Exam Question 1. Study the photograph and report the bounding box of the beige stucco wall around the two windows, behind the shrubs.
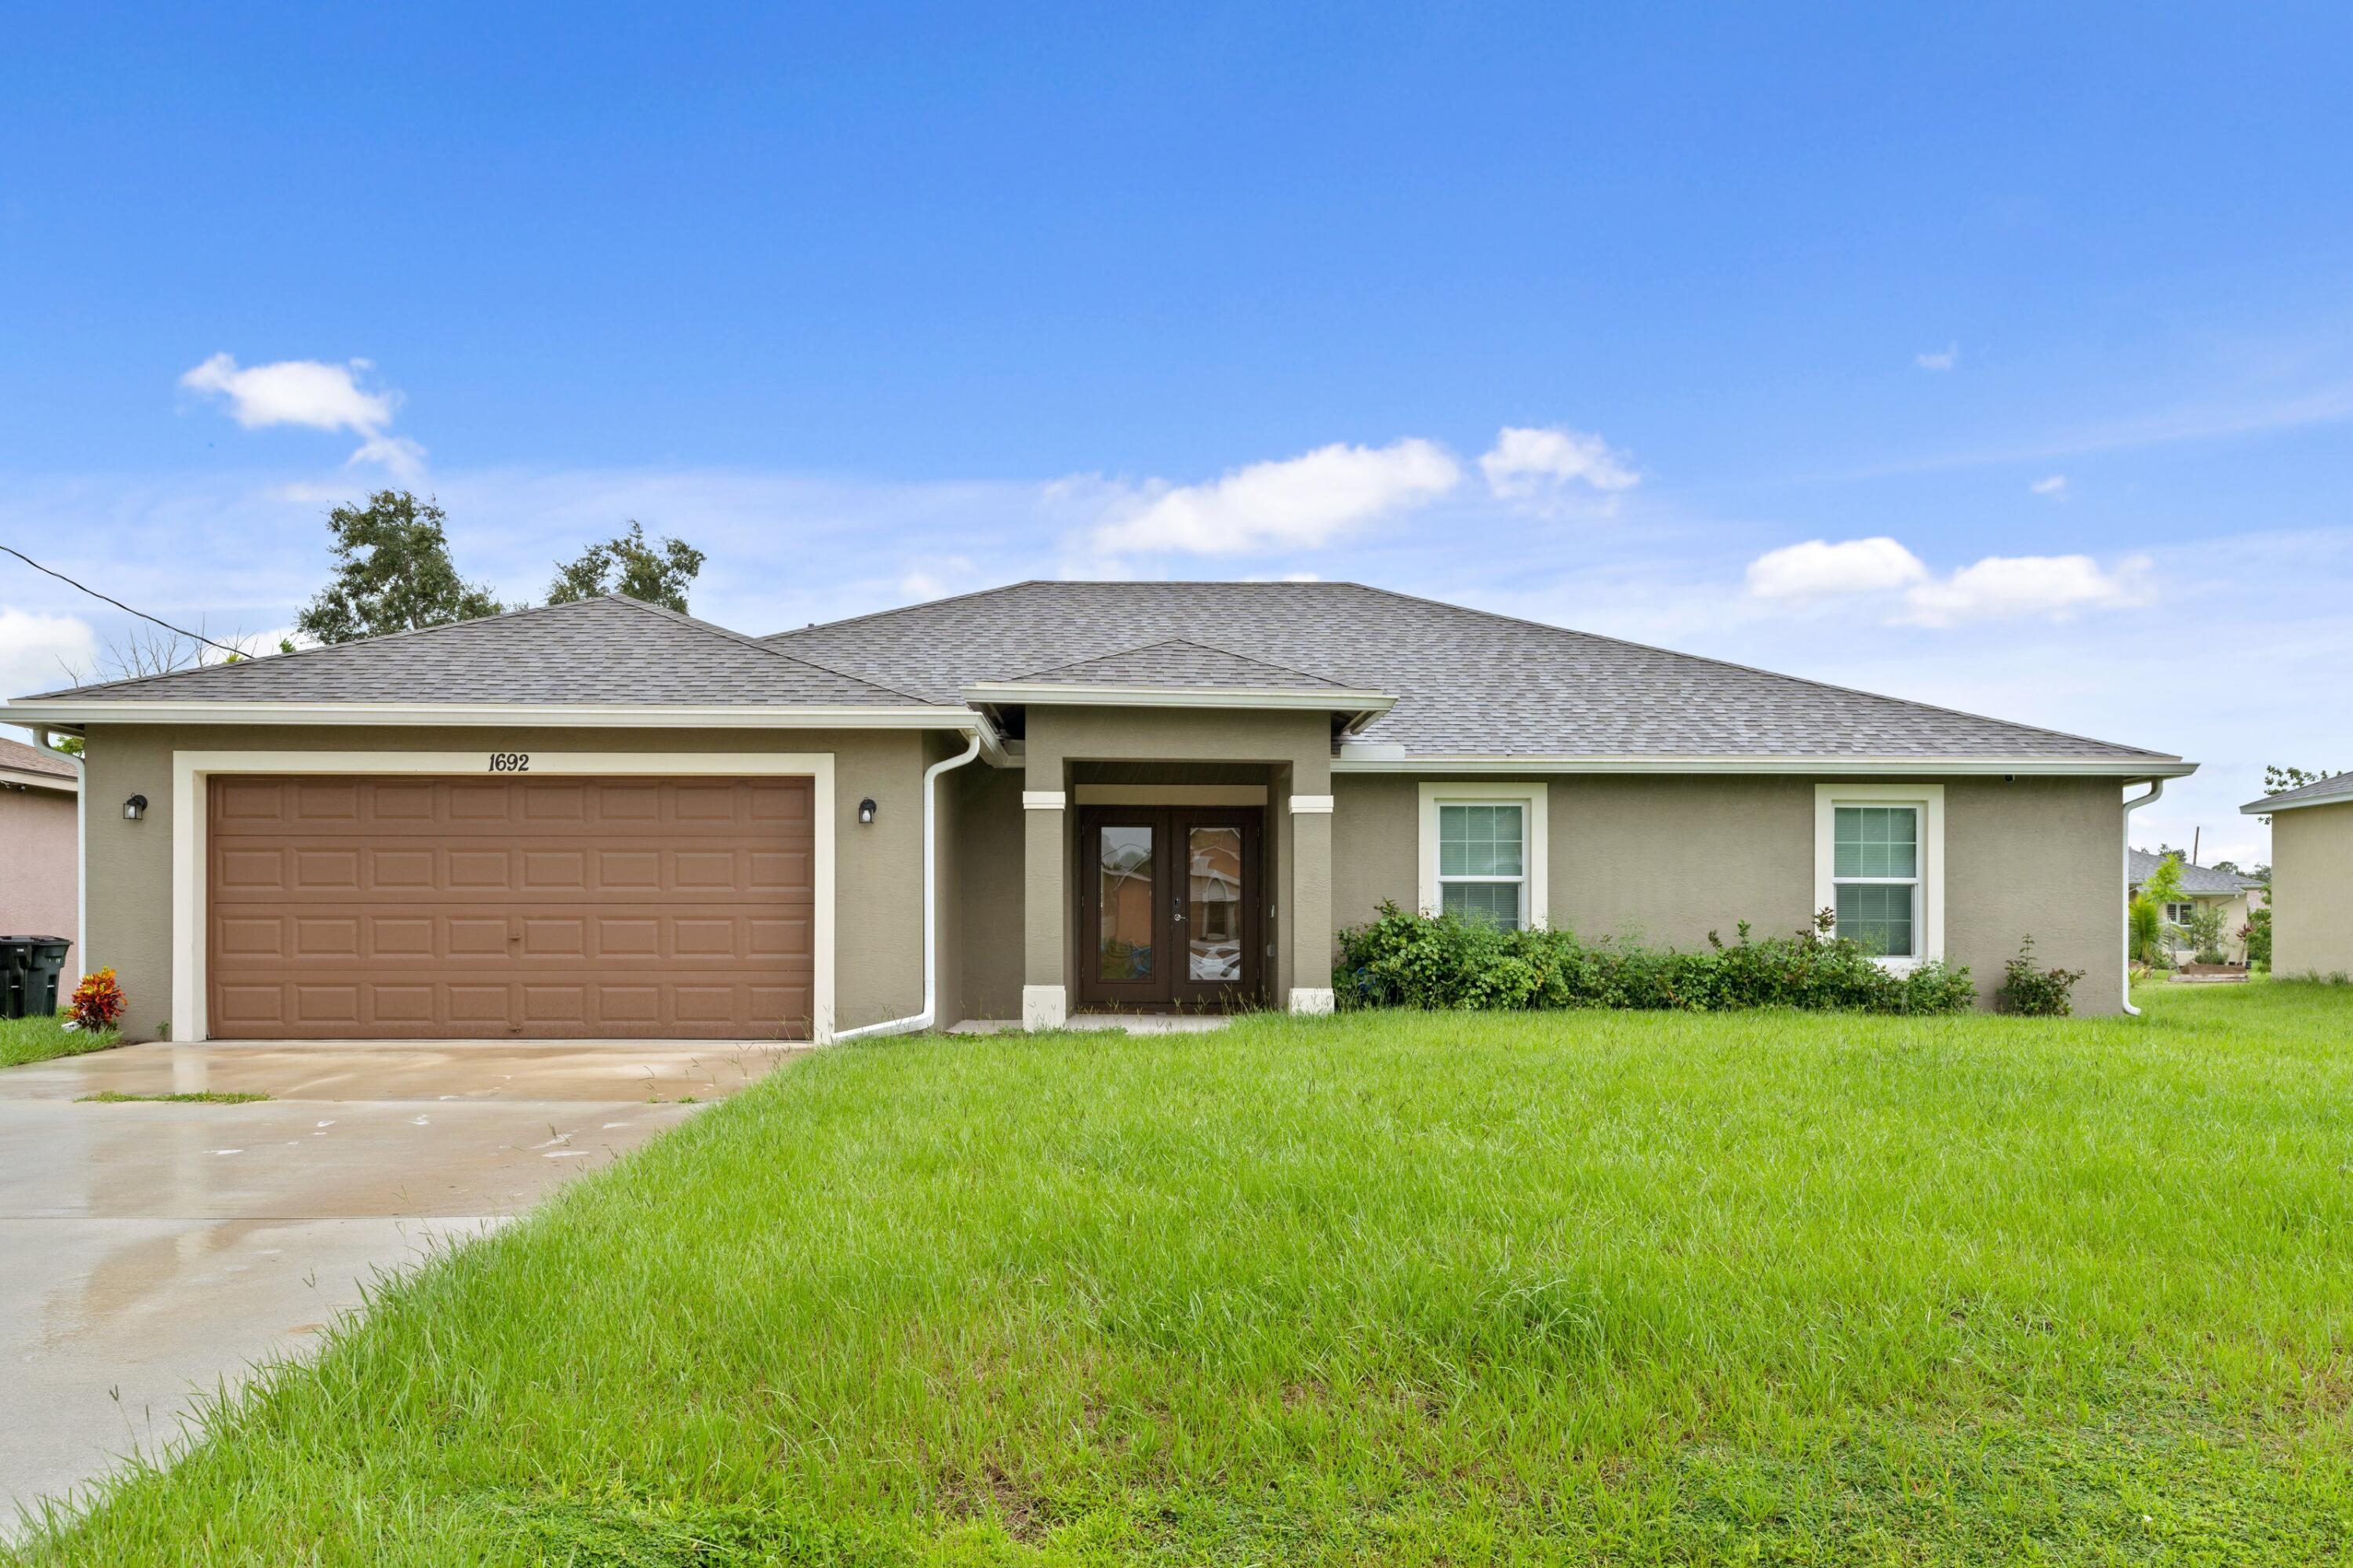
[1332,774,2122,1013]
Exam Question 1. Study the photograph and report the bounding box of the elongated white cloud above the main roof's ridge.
[1094,438,1461,555]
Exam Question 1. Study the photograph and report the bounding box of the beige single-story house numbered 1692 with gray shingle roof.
[0,581,2193,1041]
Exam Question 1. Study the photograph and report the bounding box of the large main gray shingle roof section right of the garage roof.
[765,581,2179,765]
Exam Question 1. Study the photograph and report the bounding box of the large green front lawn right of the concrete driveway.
[18,984,2353,1566]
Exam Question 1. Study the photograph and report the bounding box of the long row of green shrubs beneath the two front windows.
[1332,904,1977,1013]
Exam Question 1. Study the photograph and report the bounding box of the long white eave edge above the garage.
[0,699,981,729]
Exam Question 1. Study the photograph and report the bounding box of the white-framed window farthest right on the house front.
[1814,784,1944,968]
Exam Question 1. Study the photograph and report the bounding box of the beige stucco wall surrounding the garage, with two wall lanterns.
[85,725,953,1039]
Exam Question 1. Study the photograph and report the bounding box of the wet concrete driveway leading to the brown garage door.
[0,1043,793,1535]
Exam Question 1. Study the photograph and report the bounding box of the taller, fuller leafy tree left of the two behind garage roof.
[294,489,506,642]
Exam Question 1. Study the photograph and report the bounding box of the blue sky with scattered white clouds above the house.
[0,5,2353,857]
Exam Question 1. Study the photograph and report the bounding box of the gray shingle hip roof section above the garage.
[28,593,932,706]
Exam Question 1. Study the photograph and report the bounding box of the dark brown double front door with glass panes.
[1078,806,1266,1010]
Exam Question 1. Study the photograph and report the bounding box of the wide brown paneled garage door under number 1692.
[205,777,816,1041]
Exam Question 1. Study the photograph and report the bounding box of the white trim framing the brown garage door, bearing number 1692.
[172,751,840,1046]
